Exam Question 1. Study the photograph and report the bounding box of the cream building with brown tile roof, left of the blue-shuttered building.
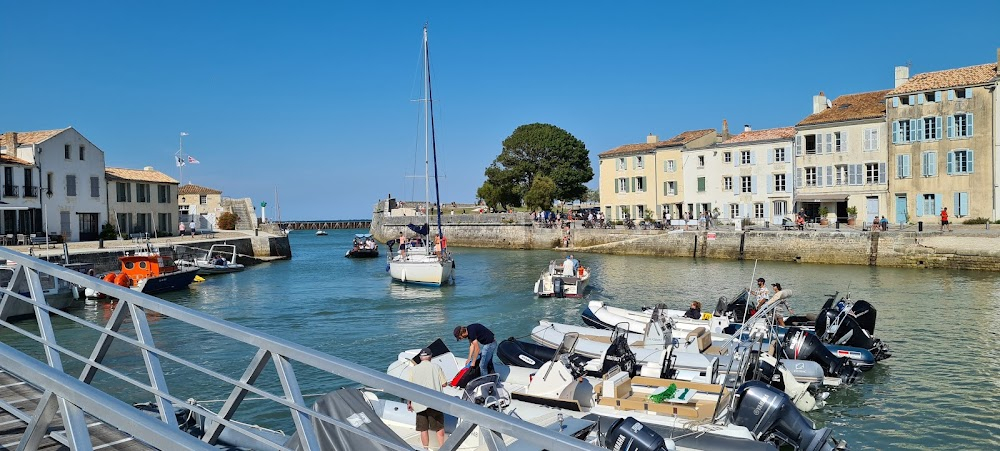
[794,90,890,223]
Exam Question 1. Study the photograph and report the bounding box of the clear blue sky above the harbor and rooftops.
[0,1,1000,220]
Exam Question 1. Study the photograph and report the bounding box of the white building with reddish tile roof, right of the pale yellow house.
[712,125,795,224]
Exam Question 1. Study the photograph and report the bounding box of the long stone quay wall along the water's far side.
[371,213,1000,271]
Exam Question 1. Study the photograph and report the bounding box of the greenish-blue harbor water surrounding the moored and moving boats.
[11,230,1000,449]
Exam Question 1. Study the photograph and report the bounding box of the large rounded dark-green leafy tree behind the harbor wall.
[477,123,594,207]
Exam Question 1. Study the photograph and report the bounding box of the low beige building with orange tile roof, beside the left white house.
[104,166,178,237]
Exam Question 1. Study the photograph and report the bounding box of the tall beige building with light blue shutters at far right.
[885,57,1000,224]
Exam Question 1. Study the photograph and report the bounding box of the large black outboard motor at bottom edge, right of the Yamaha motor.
[730,381,845,451]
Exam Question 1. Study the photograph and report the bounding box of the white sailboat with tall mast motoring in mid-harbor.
[386,25,455,286]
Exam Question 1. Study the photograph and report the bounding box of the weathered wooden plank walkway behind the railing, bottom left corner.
[0,368,155,451]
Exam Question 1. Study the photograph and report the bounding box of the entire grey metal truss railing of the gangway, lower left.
[0,247,598,450]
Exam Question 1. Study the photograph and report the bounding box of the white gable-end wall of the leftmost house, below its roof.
[17,128,107,241]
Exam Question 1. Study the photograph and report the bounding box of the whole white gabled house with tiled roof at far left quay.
[0,127,107,241]
